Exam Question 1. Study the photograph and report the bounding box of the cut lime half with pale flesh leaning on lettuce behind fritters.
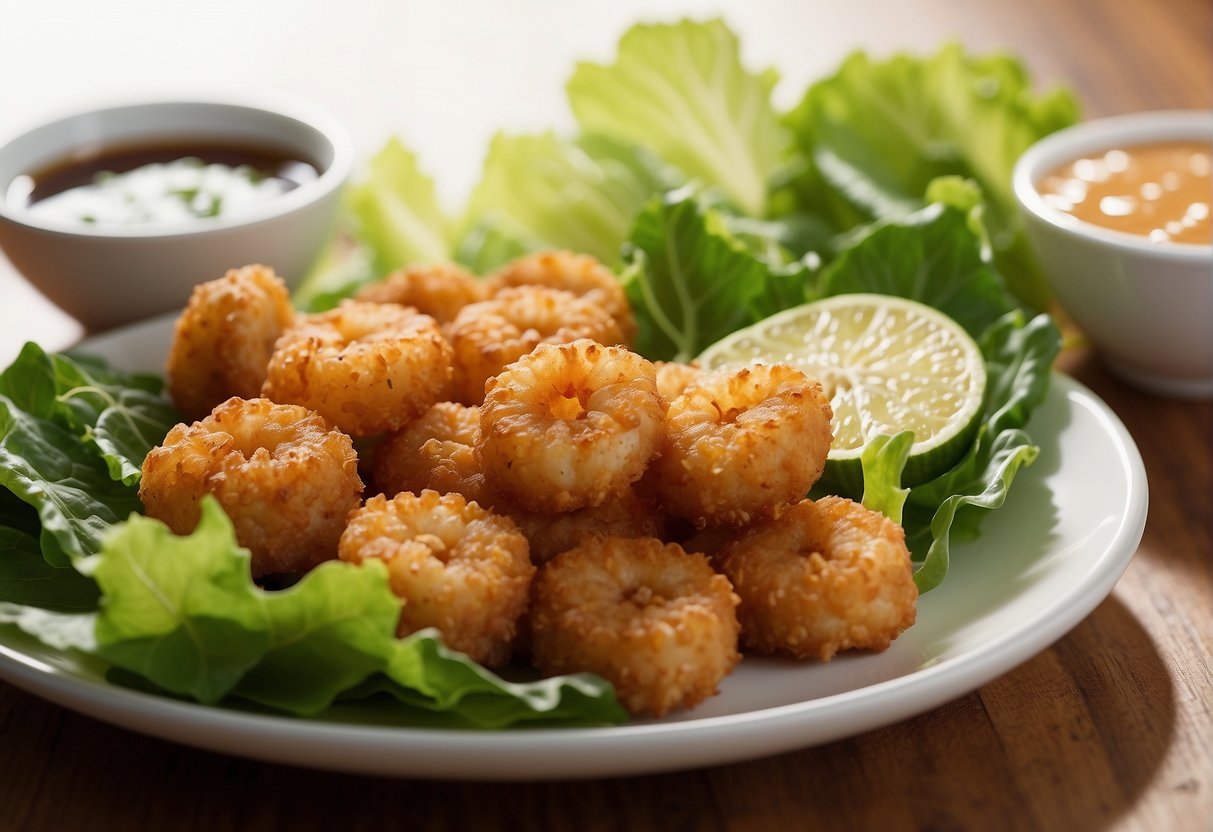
[699,295,986,497]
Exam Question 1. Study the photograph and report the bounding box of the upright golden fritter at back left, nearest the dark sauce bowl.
[165,266,295,420]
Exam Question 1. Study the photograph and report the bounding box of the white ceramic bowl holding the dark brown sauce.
[0,97,353,330]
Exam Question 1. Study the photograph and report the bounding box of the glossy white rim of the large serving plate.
[0,317,1149,780]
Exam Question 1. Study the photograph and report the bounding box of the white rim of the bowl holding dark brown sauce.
[0,92,354,240]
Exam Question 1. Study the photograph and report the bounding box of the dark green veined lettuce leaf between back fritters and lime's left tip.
[622,187,790,361]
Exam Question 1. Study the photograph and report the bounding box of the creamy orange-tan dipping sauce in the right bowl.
[1037,142,1213,245]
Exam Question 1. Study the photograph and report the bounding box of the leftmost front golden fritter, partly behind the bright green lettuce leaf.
[139,398,363,577]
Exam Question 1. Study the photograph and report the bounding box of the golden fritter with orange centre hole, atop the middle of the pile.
[475,338,662,512]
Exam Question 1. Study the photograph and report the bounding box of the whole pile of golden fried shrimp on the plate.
[139,251,917,716]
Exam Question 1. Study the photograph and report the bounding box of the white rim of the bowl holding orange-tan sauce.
[1012,109,1213,264]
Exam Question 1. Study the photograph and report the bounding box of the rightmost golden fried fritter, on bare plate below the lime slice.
[714,497,918,661]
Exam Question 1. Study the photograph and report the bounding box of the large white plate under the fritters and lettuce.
[0,319,1146,780]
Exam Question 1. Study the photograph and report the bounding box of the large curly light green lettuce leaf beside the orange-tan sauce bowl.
[785,44,1078,308]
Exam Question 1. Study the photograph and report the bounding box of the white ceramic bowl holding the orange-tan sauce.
[1013,110,1213,398]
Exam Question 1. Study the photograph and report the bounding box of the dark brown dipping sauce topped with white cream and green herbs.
[5,139,320,226]
